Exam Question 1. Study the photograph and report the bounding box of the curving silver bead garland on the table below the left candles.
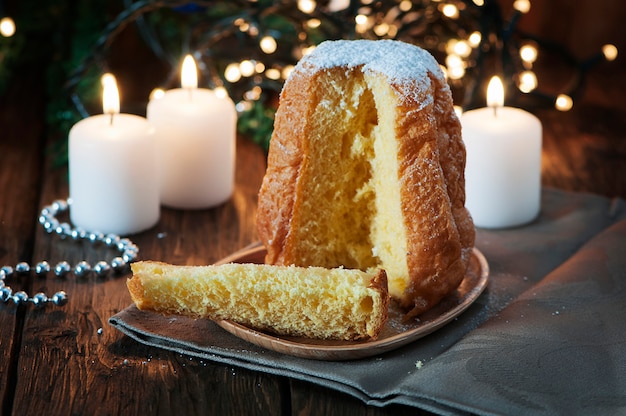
[0,200,139,308]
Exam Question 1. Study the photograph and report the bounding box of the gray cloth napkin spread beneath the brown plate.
[109,189,626,415]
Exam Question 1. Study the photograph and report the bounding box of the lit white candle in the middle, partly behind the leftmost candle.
[147,57,237,209]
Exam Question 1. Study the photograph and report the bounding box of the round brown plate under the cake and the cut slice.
[217,246,489,360]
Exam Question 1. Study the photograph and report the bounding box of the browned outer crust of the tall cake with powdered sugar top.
[257,41,475,316]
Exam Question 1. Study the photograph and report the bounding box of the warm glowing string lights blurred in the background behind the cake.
[47,0,617,153]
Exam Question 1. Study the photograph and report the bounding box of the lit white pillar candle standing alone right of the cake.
[461,77,542,228]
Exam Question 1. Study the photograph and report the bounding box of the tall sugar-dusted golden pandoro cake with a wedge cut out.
[257,40,474,316]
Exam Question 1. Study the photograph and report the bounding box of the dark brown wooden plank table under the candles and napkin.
[0,57,626,415]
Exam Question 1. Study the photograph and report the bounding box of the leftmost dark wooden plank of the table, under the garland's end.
[0,66,45,414]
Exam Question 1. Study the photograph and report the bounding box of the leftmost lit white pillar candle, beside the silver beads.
[69,76,160,235]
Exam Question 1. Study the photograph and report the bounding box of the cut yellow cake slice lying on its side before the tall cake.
[127,261,389,340]
